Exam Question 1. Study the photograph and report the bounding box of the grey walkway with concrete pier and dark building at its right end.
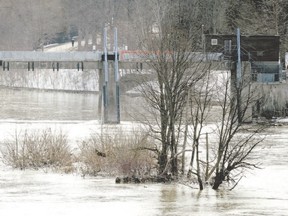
[0,35,285,123]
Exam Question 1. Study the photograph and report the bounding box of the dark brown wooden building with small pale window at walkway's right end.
[205,35,282,83]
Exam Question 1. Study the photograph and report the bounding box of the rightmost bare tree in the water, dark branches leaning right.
[207,64,265,189]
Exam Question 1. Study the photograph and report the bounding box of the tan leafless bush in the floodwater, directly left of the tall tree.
[79,131,155,176]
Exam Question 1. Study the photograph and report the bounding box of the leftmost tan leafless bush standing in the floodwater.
[1,129,72,171]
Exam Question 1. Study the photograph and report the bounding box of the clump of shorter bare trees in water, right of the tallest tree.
[180,54,266,190]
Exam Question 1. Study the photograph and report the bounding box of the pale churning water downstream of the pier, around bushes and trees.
[0,121,288,216]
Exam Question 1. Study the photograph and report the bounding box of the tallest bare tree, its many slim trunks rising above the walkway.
[132,1,210,176]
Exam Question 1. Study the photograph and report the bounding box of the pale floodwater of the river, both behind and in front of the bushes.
[0,89,288,216]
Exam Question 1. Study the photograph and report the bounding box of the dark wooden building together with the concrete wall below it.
[205,35,288,120]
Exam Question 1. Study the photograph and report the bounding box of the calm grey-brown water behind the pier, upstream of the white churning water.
[0,87,138,121]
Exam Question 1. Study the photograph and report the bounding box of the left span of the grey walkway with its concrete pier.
[0,51,120,123]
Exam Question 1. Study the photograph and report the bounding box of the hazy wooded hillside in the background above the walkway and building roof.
[0,0,288,58]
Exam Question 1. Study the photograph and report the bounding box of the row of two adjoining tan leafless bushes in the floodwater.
[1,129,157,176]
